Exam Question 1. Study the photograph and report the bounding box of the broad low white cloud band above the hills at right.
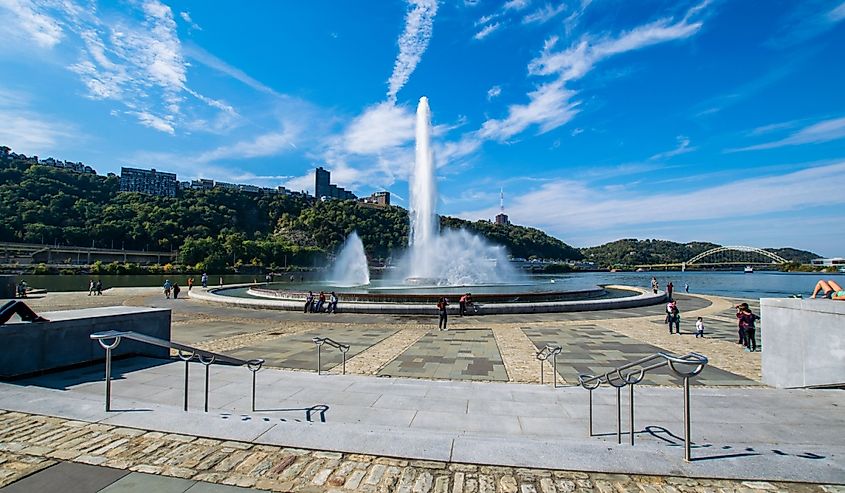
[459,161,845,234]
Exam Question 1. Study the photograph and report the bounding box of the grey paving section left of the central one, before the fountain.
[227,326,398,370]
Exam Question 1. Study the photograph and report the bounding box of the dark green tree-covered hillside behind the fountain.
[0,158,581,272]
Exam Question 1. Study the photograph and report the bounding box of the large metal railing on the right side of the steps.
[578,352,707,462]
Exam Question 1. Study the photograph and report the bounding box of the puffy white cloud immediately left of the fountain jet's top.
[343,101,416,154]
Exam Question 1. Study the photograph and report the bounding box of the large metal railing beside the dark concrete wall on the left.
[91,330,264,412]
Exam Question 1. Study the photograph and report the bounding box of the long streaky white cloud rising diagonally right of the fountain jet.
[479,2,706,140]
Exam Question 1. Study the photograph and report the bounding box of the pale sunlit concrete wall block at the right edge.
[760,298,845,388]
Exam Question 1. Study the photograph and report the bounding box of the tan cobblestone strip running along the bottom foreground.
[0,411,845,493]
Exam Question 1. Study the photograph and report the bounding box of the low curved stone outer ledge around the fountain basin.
[189,284,666,317]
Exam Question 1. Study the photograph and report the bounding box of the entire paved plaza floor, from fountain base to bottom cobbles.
[0,289,845,493]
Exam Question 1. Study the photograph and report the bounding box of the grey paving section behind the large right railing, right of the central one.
[522,323,757,386]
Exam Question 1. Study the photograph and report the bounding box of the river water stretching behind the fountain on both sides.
[13,271,845,299]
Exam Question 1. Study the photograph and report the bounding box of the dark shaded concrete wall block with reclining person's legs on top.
[0,306,170,378]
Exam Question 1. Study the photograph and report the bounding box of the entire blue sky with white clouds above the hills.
[0,0,845,256]
